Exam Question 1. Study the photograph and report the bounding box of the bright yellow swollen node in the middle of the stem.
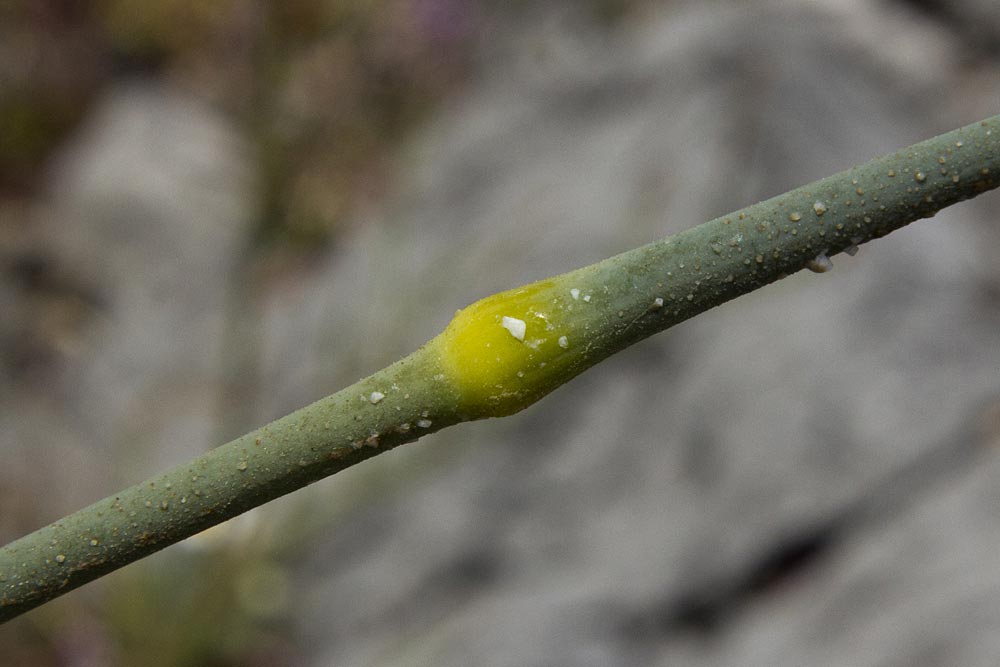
[433,274,592,417]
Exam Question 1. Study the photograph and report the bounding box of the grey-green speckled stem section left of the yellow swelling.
[0,346,461,623]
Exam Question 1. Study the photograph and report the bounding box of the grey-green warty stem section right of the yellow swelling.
[581,116,1000,366]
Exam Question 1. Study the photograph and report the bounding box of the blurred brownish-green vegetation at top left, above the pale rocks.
[0,0,478,244]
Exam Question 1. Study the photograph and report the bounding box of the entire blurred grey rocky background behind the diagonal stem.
[0,0,1000,667]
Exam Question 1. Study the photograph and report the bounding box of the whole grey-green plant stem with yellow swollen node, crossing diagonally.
[0,116,1000,622]
